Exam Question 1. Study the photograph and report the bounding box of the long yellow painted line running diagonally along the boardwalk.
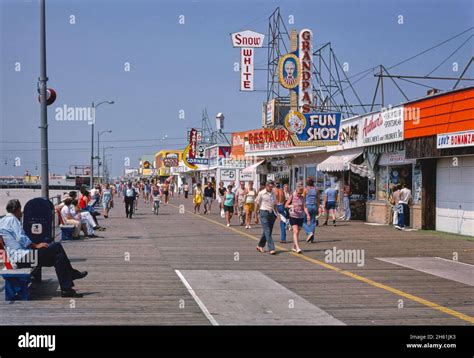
[171,204,474,324]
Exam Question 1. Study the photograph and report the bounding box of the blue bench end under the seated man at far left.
[0,236,35,301]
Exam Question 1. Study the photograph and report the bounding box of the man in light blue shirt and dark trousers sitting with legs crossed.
[0,199,87,297]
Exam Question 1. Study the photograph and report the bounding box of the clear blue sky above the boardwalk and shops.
[0,0,474,176]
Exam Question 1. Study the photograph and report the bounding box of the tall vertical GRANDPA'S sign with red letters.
[298,29,313,113]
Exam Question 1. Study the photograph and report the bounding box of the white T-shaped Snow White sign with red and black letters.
[231,30,265,91]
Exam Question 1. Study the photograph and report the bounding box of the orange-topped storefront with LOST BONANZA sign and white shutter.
[405,87,474,236]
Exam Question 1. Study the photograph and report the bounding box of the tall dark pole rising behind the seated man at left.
[39,0,49,198]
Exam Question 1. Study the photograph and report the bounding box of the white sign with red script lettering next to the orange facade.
[361,106,404,146]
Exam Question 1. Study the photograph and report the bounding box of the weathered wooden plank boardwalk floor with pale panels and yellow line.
[0,197,474,325]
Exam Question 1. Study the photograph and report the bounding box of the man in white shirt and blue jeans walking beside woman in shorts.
[255,180,277,255]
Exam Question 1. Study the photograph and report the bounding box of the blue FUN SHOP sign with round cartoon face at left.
[285,111,341,147]
